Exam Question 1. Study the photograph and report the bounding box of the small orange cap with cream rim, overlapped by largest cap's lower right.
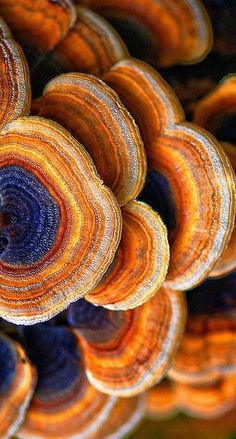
[86,201,169,310]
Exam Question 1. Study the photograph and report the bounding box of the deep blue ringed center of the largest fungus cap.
[0,166,60,265]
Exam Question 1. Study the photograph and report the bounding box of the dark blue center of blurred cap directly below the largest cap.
[24,324,80,400]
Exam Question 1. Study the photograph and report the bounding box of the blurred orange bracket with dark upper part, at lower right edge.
[168,273,236,385]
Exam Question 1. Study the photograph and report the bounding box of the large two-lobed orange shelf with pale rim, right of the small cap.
[104,59,235,290]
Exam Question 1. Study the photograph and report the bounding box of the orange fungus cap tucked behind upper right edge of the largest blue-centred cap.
[33,73,146,205]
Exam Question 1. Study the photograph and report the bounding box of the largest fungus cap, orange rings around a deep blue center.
[0,117,121,324]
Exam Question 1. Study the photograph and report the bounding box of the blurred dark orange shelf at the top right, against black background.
[76,0,212,67]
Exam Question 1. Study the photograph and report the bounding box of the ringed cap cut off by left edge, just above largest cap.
[0,18,31,130]
